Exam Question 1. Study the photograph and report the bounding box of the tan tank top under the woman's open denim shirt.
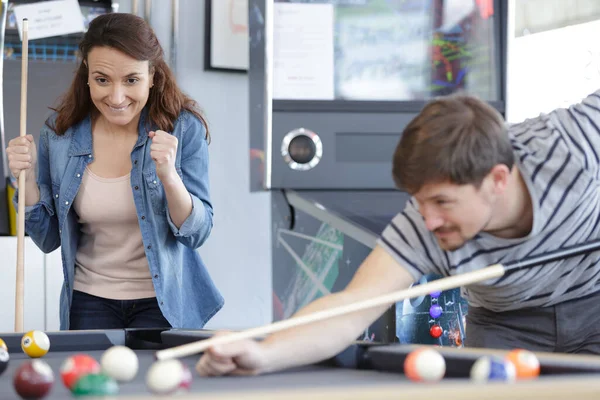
[73,168,156,300]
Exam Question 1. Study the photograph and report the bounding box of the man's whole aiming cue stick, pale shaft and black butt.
[156,240,600,360]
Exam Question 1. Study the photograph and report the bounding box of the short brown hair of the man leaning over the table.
[392,94,514,194]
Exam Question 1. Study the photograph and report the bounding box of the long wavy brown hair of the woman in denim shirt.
[47,13,210,139]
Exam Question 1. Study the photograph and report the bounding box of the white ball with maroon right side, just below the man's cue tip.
[146,359,192,395]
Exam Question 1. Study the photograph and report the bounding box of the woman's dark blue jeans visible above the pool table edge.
[69,290,171,330]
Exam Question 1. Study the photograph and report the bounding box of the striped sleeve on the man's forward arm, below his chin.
[377,201,447,280]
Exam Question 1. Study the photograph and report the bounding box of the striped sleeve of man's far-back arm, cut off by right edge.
[552,90,600,177]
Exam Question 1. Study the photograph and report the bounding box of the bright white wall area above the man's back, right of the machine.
[507,8,600,123]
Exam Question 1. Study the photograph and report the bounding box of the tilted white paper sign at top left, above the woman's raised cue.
[14,0,85,40]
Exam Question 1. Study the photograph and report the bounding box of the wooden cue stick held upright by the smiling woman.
[15,18,29,332]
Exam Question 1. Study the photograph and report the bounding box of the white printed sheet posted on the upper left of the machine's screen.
[273,3,334,100]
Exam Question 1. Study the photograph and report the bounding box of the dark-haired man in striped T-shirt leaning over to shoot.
[197,91,600,375]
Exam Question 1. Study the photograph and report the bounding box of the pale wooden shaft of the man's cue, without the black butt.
[155,264,506,360]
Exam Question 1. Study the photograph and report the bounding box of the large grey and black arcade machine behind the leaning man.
[249,0,508,346]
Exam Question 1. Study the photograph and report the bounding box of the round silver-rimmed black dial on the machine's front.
[281,128,323,171]
